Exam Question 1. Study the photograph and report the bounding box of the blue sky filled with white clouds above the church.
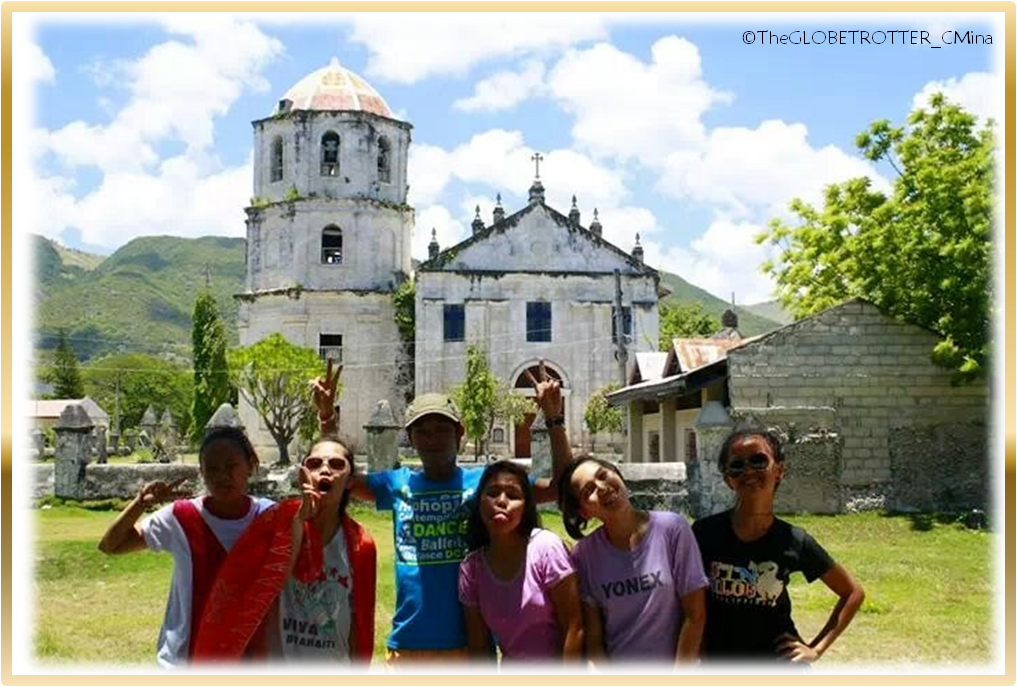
[18,12,1004,303]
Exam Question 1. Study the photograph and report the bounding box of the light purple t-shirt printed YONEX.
[573,511,709,675]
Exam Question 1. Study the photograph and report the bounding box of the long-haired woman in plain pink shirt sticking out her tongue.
[459,460,583,675]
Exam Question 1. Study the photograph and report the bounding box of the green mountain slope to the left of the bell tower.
[21,236,245,360]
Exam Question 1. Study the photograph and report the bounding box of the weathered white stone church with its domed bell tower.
[237,60,666,458]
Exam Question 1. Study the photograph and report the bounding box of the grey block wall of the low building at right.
[727,300,991,509]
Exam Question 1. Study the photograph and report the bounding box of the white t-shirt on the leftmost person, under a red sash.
[139,497,276,675]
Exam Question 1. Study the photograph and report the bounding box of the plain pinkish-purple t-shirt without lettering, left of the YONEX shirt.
[459,528,577,675]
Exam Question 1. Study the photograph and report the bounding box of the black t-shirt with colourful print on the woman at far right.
[693,511,834,675]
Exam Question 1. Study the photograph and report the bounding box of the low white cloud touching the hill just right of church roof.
[643,216,773,303]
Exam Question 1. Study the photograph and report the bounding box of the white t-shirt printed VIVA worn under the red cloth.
[263,527,353,675]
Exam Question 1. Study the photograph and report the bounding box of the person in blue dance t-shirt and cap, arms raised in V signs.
[312,361,572,675]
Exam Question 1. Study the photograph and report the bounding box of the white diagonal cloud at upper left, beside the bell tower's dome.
[24,13,283,173]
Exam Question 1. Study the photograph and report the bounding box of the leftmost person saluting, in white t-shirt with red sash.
[99,427,275,675]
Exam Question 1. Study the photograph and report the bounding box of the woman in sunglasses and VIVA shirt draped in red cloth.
[193,438,376,675]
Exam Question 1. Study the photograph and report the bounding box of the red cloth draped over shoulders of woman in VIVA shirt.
[191,500,376,675]
